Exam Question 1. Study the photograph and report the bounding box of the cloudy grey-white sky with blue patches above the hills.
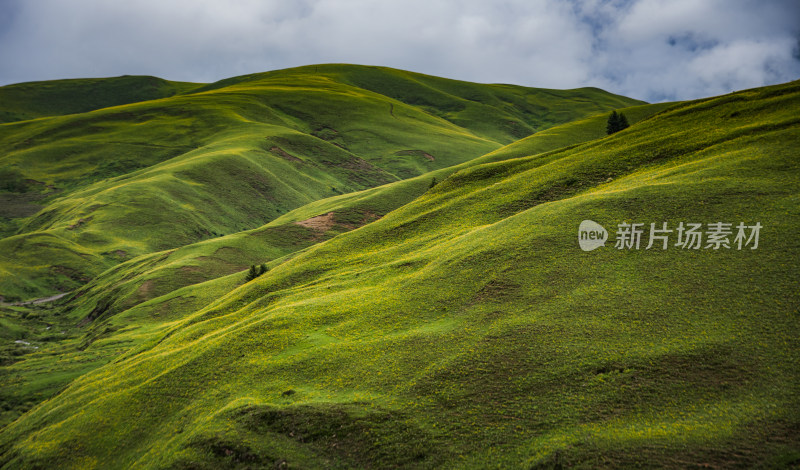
[0,0,800,102]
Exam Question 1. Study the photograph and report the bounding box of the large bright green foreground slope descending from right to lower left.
[0,82,800,468]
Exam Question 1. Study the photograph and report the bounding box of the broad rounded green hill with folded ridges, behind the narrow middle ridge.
[0,65,635,298]
